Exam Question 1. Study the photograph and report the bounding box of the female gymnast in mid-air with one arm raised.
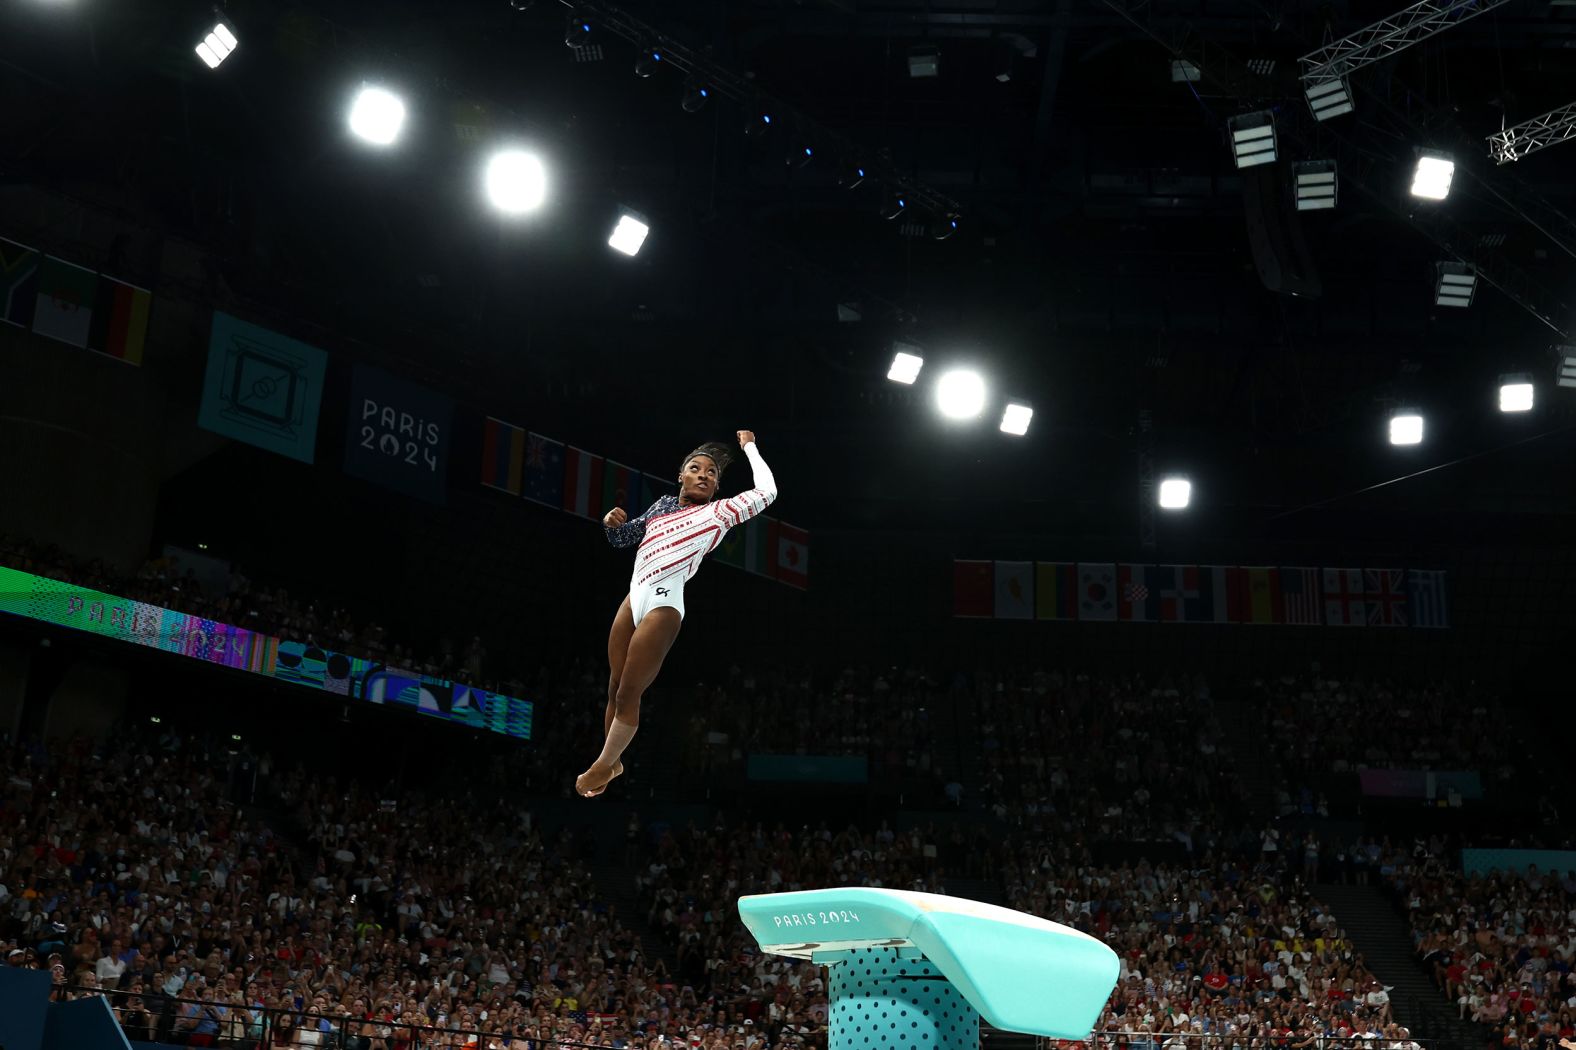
[575,430,777,798]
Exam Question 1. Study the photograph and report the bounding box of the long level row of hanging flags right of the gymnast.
[952,558,1450,627]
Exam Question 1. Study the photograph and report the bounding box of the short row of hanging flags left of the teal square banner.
[0,236,153,364]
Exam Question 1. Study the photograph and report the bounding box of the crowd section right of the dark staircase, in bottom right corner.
[1381,840,1576,1050]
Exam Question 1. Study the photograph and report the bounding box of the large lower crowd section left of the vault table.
[0,733,815,1050]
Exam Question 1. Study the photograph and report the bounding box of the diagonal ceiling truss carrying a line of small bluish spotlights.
[559,0,963,214]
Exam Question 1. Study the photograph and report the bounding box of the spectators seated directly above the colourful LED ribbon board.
[0,533,491,695]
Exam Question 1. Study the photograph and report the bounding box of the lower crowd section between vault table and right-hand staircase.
[1002,842,1415,1048]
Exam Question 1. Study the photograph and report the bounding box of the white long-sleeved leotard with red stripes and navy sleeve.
[604,441,777,624]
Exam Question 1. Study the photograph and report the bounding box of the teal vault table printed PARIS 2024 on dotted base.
[739,886,1119,1050]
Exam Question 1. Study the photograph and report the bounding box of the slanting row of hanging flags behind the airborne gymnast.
[481,416,806,589]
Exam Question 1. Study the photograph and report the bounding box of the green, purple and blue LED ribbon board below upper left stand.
[0,566,534,739]
